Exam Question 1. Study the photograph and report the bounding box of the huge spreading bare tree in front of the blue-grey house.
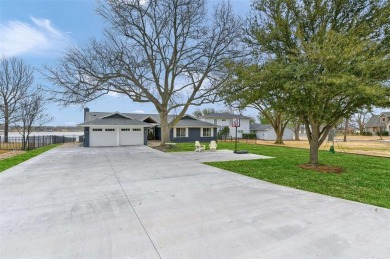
[45,0,242,144]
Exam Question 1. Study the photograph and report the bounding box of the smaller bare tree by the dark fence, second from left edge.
[15,89,53,149]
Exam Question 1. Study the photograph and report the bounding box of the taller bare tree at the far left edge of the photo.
[0,57,34,142]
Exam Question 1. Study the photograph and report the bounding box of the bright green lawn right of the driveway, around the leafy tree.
[171,142,390,208]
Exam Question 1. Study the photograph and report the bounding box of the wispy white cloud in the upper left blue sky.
[0,17,69,56]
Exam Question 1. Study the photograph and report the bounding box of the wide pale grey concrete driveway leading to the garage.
[0,147,390,258]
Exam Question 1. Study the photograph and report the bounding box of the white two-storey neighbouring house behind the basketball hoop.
[199,113,251,138]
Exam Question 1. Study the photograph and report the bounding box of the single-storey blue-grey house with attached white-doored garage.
[78,108,217,147]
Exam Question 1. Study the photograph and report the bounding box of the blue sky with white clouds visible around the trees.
[0,0,253,125]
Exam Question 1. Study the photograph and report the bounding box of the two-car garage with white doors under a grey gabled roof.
[80,113,149,147]
